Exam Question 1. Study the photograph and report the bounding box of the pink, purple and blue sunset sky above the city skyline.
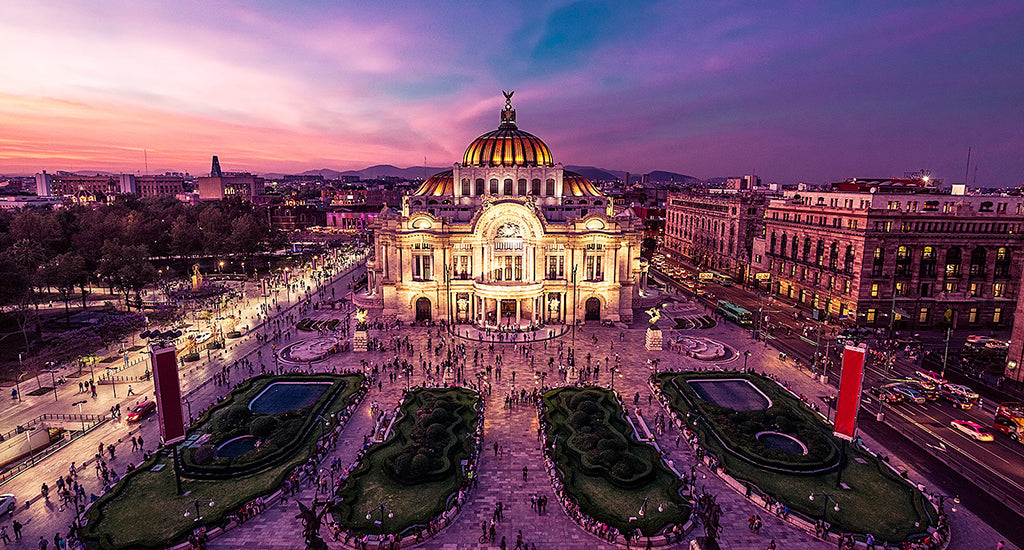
[0,0,1024,186]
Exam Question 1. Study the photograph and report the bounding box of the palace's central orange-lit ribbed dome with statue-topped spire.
[462,92,555,166]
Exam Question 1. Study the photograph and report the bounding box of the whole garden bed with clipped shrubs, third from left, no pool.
[544,387,690,536]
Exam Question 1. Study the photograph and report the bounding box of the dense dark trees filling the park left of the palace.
[0,197,273,348]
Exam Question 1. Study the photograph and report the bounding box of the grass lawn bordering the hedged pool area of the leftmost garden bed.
[83,375,362,550]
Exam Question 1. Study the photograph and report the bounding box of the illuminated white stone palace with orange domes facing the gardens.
[356,93,642,330]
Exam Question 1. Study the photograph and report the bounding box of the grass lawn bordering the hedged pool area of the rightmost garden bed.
[659,373,934,542]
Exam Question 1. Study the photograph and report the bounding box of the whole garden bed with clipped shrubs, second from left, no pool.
[333,388,479,535]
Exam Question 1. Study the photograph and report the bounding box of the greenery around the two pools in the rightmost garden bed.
[657,372,935,542]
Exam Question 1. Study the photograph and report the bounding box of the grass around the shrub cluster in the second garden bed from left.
[334,388,477,535]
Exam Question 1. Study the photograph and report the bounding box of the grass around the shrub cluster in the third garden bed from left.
[544,388,690,536]
